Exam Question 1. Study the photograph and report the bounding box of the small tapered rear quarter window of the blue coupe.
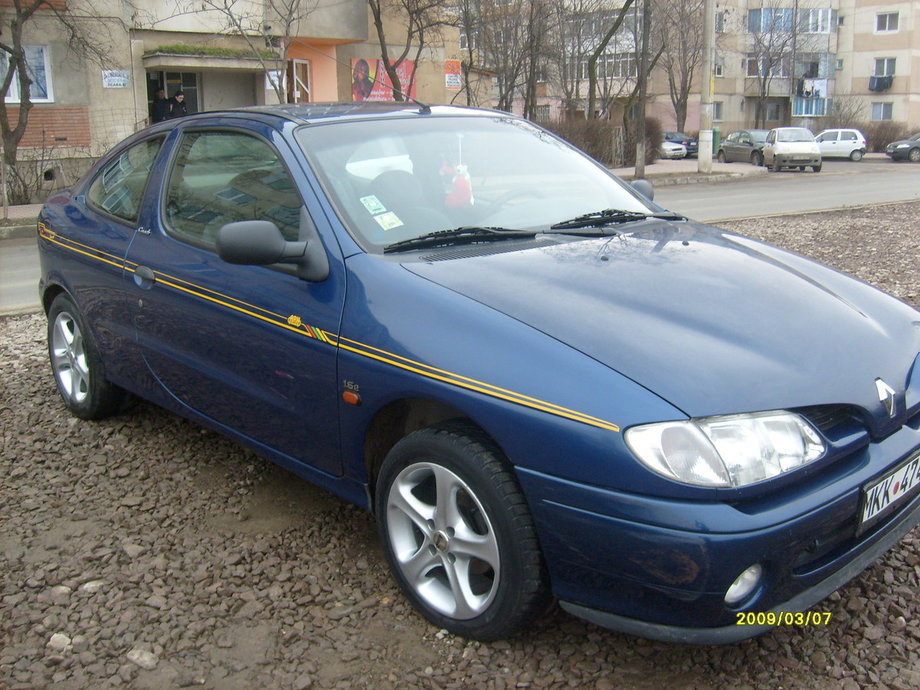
[86,137,163,222]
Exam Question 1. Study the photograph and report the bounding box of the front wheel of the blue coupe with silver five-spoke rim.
[375,421,549,641]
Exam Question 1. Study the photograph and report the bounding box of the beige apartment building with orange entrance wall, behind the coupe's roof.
[0,0,468,197]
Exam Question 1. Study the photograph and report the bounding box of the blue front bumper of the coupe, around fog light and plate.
[518,425,920,644]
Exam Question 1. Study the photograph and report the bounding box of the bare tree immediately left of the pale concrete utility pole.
[653,0,705,131]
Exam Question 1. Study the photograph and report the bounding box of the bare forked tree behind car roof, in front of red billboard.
[367,0,449,101]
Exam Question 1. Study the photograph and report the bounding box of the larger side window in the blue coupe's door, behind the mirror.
[165,132,301,247]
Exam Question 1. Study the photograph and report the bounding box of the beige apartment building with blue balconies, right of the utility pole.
[700,0,920,131]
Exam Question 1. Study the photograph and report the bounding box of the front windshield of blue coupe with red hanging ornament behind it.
[297,116,660,253]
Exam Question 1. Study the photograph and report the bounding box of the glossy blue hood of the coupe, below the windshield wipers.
[404,221,920,423]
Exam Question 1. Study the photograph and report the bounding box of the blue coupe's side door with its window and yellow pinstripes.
[127,125,345,474]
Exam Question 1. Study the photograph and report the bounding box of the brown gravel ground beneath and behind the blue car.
[0,203,920,690]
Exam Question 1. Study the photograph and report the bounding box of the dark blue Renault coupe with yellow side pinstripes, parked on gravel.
[38,104,920,644]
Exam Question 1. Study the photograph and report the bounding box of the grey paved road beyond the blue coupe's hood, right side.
[655,159,920,221]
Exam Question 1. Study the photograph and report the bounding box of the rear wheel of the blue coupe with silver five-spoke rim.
[48,294,129,419]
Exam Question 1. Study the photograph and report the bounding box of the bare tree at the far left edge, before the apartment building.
[0,0,117,204]
